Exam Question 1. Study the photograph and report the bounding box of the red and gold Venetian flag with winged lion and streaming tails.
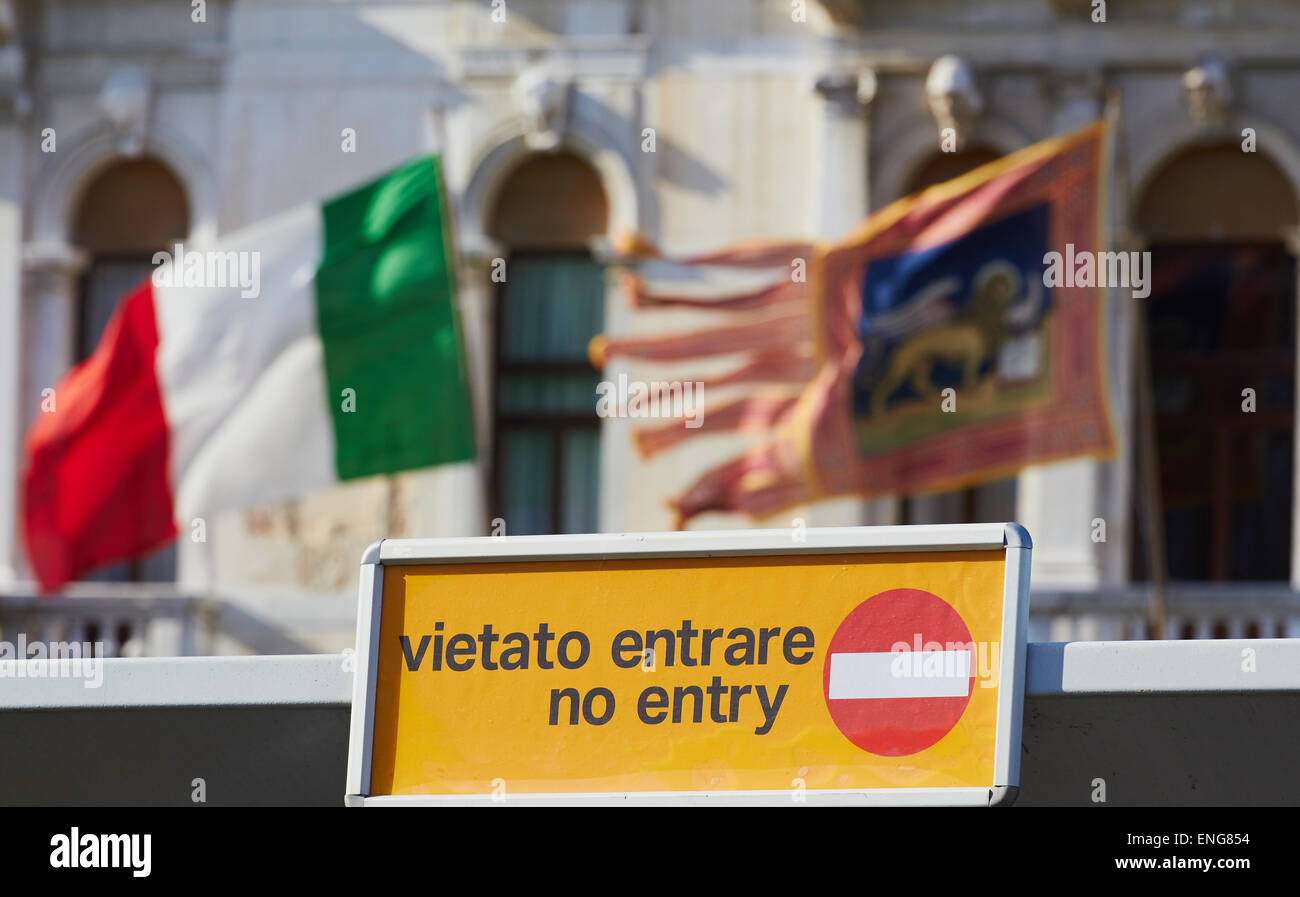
[590,122,1114,527]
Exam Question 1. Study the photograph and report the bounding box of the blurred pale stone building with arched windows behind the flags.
[0,0,1300,654]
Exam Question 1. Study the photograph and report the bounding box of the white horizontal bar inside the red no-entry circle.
[829,651,971,701]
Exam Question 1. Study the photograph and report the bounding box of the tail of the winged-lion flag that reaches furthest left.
[588,311,813,368]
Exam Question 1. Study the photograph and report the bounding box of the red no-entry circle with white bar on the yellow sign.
[822,589,978,757]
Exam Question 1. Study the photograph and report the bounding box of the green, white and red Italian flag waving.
[22,157,475,590]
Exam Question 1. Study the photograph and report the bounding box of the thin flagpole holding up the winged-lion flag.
[1105,86,1167,638]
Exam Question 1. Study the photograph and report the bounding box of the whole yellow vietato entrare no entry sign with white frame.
[347,524,1030,805]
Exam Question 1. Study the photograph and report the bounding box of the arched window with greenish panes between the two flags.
[489,153,608,534]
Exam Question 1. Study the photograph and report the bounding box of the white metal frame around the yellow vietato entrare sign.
[345,523,1032,806]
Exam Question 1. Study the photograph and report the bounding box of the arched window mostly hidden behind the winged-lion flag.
[900,146,1015,524]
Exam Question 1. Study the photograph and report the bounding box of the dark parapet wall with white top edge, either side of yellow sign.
[0,638,1300,806]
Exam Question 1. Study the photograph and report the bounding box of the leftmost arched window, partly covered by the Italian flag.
[73,159,190,582]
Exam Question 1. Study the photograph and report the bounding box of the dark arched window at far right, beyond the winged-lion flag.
[1132,143,1300,580]
